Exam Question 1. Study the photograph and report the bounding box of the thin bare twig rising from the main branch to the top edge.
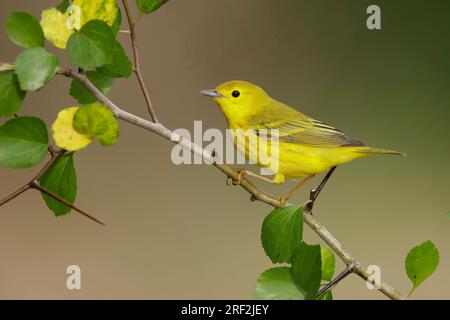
[122,0,159,123]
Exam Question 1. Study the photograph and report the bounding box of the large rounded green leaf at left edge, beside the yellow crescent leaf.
[0,117,48,169]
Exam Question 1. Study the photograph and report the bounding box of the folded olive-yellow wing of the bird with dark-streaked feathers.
[252,102,364,148]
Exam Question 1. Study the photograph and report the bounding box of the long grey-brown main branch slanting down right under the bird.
[59,69,406,300]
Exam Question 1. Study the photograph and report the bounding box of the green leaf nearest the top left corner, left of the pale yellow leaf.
[5,11,44,48]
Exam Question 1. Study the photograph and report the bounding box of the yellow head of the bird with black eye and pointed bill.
[201,80,272,124]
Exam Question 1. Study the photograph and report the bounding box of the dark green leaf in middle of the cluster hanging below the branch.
[291,242,322,299]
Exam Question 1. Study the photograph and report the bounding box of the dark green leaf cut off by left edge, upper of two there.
[0,70,26,117]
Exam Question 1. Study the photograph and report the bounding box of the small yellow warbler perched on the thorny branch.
[201,81,404,204]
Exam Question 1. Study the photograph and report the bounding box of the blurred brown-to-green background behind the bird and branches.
[0,0,450,299]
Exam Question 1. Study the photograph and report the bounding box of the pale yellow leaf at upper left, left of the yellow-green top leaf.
[41,8,74,49]
